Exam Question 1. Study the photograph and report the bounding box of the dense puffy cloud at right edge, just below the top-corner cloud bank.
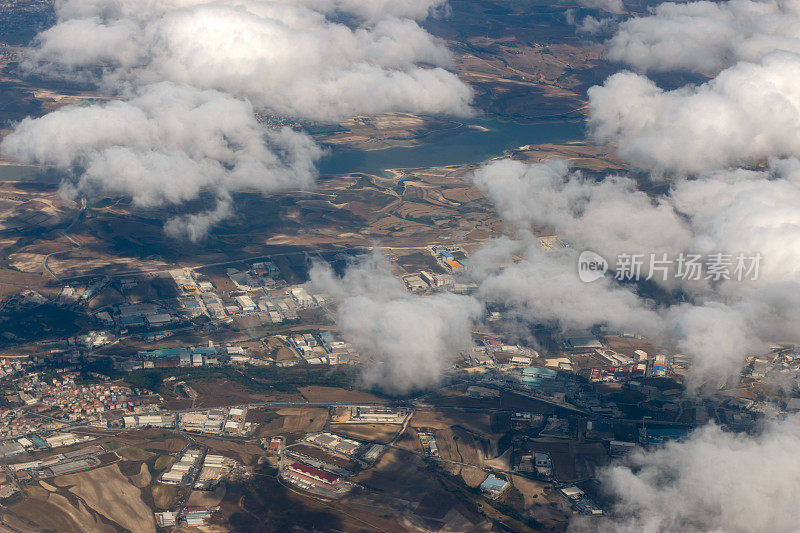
[589,52,800,174]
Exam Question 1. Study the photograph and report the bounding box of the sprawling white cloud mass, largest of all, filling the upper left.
[0,0,472,240]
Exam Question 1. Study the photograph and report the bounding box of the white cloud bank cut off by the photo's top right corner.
[608,0,800,73]
